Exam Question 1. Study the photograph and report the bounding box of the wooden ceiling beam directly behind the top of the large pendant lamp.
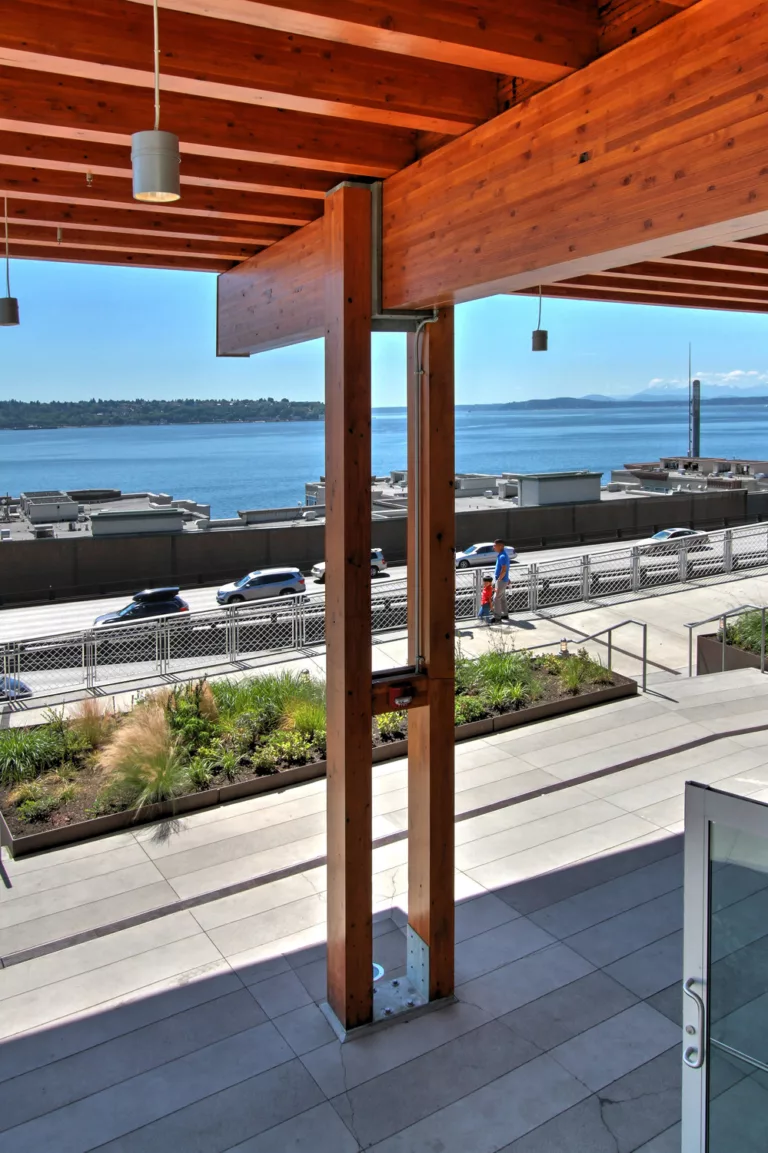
[0,66,416,176]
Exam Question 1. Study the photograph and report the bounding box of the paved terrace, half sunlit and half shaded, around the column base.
[0,670,768,1153]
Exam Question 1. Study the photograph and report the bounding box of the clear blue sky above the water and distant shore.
[0,261,768,406]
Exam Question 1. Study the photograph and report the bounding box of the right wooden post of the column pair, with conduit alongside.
[408,308,455,1001]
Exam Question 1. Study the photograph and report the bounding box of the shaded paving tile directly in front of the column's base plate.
[301,1003,490,1098]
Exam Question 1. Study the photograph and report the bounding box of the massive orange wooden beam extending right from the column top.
[384,0,768,309]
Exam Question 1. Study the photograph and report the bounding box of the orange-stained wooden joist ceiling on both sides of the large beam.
[0,0,701,276]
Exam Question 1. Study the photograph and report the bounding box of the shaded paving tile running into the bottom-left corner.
[3,1022,293,1153]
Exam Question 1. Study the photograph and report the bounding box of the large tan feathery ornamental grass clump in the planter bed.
[99,703,187,808]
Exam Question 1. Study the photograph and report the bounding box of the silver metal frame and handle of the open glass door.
[682,782,768,1153]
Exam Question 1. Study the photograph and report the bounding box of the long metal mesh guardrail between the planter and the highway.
[5,525,768,696]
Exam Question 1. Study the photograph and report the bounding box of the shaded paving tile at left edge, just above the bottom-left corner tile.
[0,988,266,1130]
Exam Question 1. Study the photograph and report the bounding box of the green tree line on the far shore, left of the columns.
[0,397,325,429]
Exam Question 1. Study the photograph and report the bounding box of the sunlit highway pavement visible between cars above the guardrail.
[0,541,696,642]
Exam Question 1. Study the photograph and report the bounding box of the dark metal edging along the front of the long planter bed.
[0,673,631,859]
